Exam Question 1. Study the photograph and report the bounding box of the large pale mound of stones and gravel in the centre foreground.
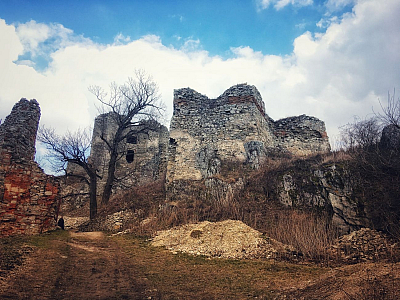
[151,220,294,259]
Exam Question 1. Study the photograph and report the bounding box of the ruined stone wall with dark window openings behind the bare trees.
[89,113,169,194]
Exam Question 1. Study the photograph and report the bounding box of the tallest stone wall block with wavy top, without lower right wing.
[167,85,275,182]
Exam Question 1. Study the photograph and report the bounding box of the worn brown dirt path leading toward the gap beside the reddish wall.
[0,232,152,299]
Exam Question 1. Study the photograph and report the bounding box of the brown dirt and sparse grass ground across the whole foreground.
[0,230,400,300]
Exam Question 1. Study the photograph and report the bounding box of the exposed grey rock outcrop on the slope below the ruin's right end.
[276,162,370,234]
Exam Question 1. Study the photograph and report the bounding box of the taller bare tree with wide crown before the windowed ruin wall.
[89,70,162,204]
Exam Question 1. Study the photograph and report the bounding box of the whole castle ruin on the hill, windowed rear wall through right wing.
[81,84,330,205]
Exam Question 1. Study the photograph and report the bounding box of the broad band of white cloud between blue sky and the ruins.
[0,0,400,168]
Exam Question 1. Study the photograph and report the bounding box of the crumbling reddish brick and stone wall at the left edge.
[0,99,59,236]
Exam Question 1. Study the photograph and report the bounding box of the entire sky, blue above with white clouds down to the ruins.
[0,0,400,166]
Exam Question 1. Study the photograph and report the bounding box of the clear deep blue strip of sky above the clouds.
[0,0,353,57]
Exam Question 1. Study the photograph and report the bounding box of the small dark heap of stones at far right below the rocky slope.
[329,228,400,263]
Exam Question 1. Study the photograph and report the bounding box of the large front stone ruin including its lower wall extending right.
[166,84,330,199]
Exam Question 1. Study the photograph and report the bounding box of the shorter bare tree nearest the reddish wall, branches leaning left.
[38,127,98,219]
